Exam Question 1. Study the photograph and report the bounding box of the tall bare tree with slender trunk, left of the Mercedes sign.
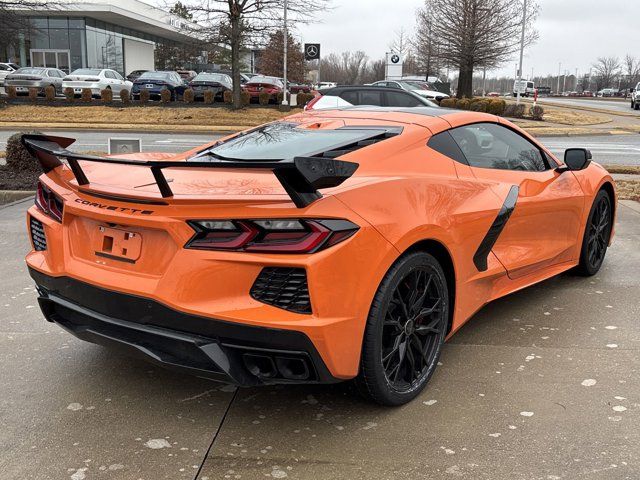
[183,0,331,108]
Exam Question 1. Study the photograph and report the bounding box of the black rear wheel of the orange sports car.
[355,252,449,406]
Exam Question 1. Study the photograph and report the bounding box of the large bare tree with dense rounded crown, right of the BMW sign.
[418,0,538,98]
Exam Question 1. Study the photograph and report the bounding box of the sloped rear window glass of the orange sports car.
[190,122,386,161]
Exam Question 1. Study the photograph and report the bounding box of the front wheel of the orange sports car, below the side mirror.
[575,190,613,277]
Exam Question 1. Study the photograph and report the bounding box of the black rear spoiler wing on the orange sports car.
[22,135,358,208]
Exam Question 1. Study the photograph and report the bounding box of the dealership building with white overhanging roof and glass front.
[10,0,196,75]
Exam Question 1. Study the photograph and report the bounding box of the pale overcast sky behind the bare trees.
[297,0,640,76]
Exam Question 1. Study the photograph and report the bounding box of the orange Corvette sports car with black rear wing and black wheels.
[23,107,616,405]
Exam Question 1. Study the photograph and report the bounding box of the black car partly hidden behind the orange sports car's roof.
[304,86,438,110]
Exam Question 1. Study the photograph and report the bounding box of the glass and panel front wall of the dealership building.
[25,16,175,75]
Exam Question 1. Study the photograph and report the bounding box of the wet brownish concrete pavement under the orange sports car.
[0,200,640,480]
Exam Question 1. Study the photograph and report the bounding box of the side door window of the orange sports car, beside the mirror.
[451,123,548,172]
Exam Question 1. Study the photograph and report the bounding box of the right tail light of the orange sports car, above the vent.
[185,218,359,253]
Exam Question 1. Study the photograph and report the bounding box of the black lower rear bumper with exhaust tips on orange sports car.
[29,268,338,386]
